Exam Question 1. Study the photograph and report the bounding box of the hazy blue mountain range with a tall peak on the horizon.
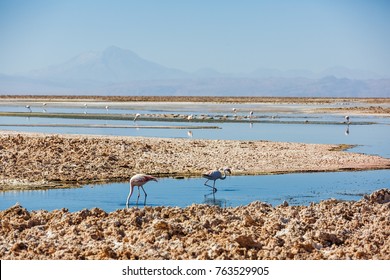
[0,46,390,97]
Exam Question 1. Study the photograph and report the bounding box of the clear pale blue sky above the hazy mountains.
[0,0,390,76]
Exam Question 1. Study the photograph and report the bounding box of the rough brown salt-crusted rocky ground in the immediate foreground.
[0,189,390,260]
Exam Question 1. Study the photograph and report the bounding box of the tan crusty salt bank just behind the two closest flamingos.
[0,131,390,190]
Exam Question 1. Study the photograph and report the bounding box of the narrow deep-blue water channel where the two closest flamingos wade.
[0,170,390,212]
